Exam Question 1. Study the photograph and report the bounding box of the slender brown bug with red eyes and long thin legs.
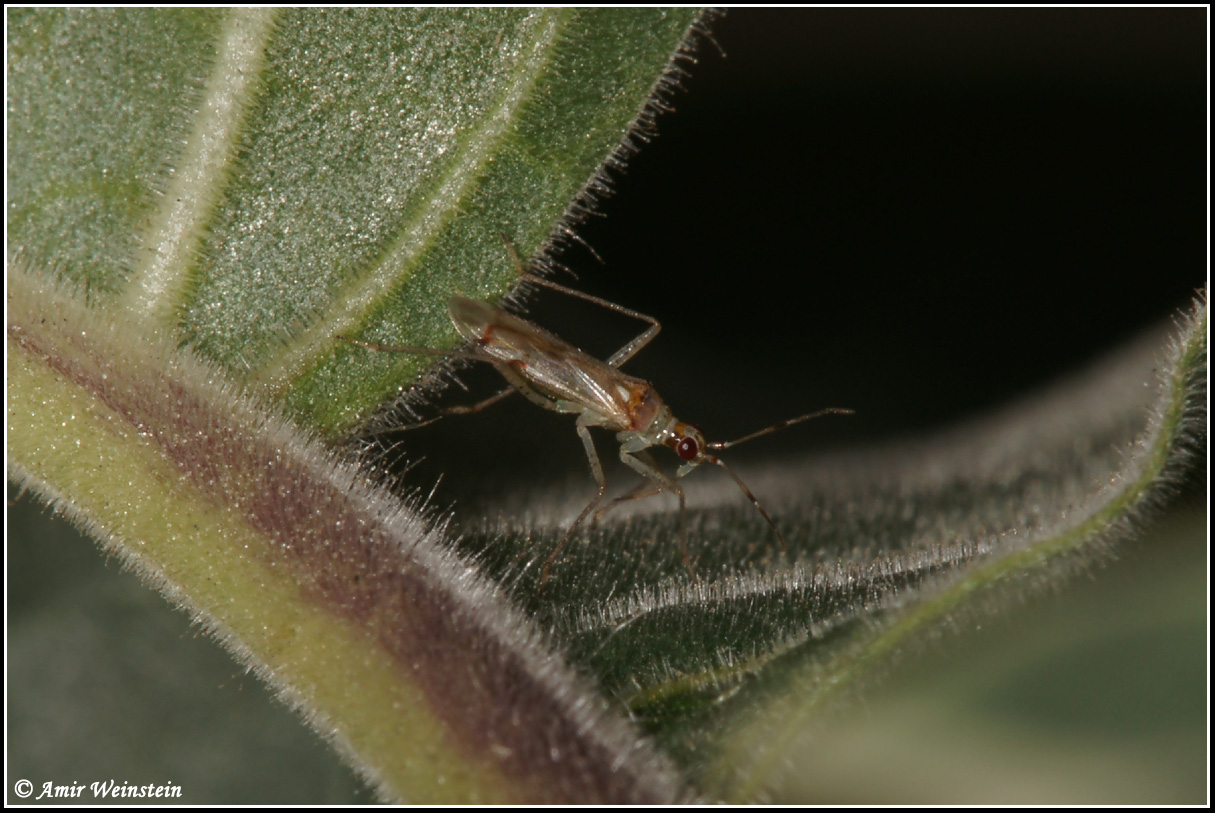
[334,238,853,588]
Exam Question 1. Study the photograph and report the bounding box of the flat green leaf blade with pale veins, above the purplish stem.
[10,9,694,433]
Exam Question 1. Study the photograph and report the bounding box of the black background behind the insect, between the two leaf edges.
[392,9,1206,513]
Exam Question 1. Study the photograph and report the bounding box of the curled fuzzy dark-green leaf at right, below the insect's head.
[432,295,1206,802]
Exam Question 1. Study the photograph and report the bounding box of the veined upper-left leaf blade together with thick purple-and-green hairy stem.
[9,10,697,801]
